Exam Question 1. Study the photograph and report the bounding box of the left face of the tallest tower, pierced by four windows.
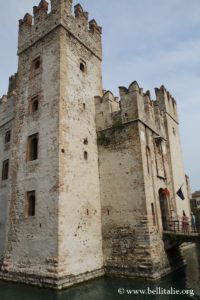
[4,32,59,274]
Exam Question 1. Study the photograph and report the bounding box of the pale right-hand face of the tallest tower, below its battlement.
[58,25,103,275]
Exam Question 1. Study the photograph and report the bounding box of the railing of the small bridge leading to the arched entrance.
[163,220,200,234]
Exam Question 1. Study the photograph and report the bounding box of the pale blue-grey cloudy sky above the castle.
[0,0,200,190]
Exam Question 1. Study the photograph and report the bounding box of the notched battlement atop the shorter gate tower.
[95,81,172,136]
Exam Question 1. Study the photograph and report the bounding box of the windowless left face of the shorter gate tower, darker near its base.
[98,123,152,276]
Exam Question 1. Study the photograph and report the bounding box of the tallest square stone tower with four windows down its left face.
[1,0,102,288]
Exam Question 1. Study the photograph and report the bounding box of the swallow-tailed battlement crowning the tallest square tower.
[18,0,102,59]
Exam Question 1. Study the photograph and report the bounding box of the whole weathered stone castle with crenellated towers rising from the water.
[0,0,190,289]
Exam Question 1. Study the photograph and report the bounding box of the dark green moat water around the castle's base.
[0,246,200,300]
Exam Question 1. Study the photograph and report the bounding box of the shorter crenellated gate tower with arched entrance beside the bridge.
[96,81,189,279]
